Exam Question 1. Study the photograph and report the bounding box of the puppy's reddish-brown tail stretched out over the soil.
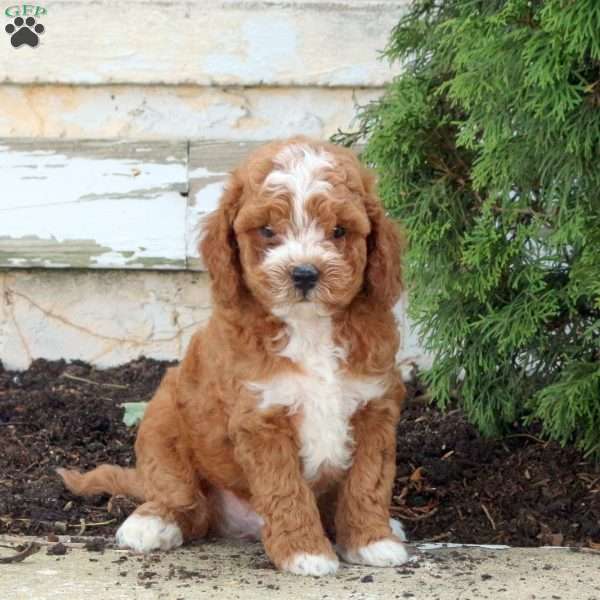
[56,465,144,500]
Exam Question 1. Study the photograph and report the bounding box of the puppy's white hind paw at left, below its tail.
[117,513,183,553]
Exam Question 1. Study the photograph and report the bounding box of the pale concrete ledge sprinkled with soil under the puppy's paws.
[0,537,600,600]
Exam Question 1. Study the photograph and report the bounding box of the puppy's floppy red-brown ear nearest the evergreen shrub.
[361,167,404,308]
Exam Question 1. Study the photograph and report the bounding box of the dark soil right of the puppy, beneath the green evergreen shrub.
[392,387,600,548]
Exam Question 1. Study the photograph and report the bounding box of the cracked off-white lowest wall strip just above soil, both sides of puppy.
[0,269,430,372]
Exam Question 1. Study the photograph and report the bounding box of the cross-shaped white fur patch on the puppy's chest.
[250,311,384,479]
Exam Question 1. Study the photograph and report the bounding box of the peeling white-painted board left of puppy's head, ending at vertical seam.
[0,139,188,269]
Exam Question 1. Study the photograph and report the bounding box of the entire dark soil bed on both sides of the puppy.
[0,359,600,549]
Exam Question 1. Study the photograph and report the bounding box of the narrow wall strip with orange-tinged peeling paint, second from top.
[0,85,382,141]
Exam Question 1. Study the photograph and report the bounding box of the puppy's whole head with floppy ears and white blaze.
[201,138,400,318]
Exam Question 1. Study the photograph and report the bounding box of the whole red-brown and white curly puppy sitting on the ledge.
[59,138,407,576]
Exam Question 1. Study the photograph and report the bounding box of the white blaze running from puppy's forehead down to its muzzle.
[263,144,338,288]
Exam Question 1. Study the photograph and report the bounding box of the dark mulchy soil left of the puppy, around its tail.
[0,360,168,535]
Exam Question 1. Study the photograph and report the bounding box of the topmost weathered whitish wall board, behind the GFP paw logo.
[0,0,408,87]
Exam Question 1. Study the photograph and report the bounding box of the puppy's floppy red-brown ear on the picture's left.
[200,172,245,307]
